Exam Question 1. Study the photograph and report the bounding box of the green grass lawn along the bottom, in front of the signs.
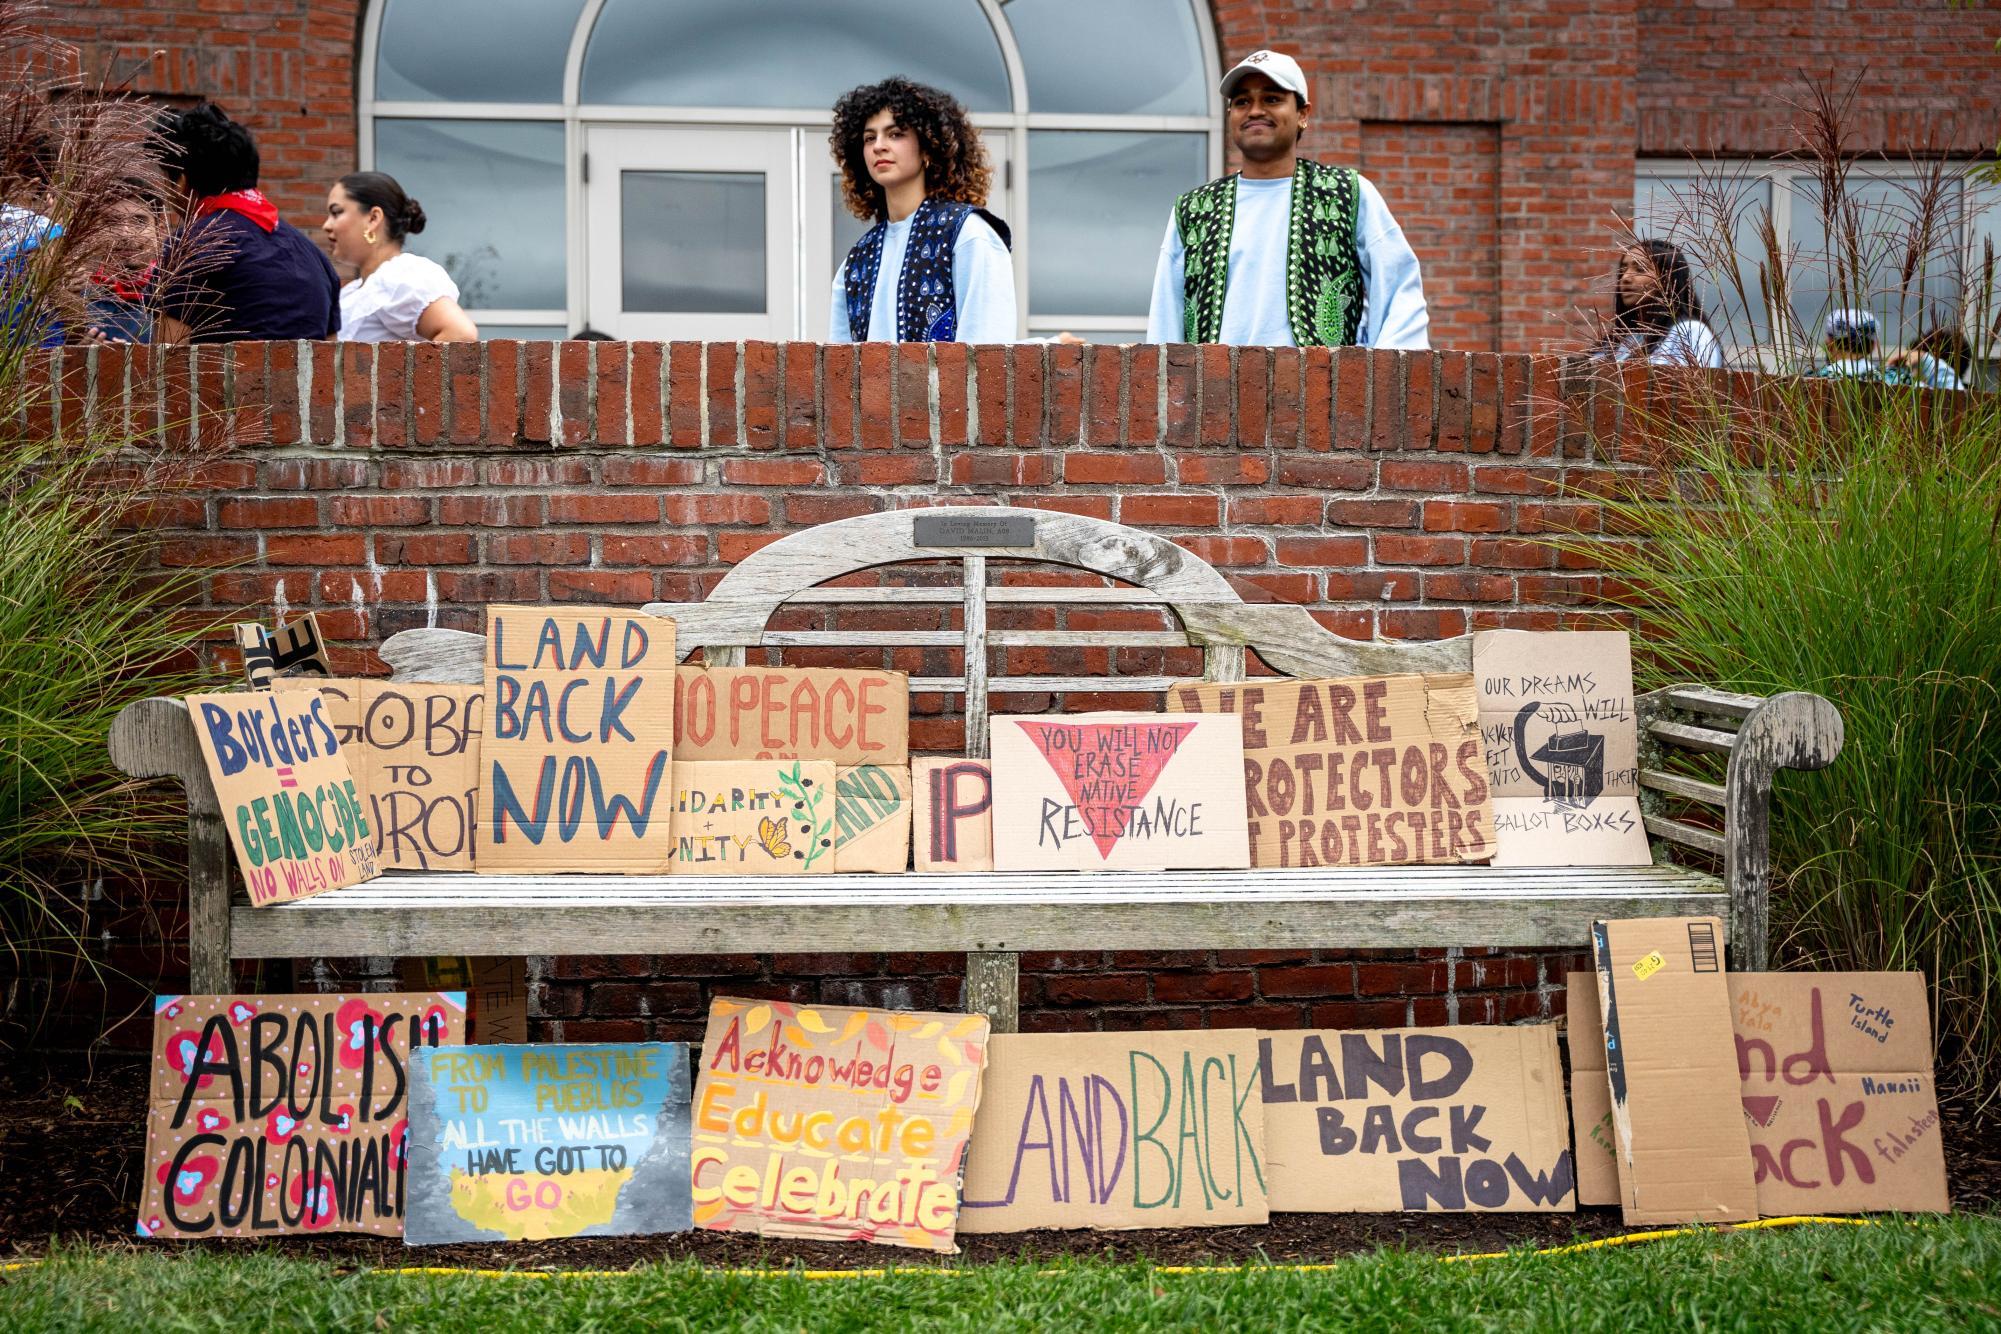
[0,1214,2001,1334]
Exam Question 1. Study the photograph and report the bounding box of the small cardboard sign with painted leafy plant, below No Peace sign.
[666,760,836,876]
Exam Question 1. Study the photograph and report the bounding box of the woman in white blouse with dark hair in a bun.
[324,172,480,342]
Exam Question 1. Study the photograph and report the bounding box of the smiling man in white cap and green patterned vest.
[1147,50,1431,348]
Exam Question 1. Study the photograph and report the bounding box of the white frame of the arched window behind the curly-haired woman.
[356,0,1223,342]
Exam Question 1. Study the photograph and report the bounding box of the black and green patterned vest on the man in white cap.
[1175,158,1363,348]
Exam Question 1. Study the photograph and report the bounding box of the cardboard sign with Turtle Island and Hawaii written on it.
[1729,972,1951,1216]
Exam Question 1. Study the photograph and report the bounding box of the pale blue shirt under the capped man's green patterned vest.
[1147,176,1431,350]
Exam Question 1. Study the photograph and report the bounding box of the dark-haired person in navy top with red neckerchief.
[154,102,340,342]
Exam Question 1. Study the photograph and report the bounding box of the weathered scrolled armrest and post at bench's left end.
[110,696,234,994]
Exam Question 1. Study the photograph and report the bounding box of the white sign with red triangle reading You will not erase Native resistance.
[990,714,1251,870]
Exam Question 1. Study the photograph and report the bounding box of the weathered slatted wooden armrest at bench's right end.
[1637,686,1843,972]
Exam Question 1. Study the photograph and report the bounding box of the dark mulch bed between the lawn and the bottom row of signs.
[0,1056,2001,1270]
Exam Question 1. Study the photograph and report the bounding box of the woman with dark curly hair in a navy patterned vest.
[826,78,1015,342]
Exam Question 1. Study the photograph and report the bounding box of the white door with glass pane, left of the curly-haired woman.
[584,126,800,342]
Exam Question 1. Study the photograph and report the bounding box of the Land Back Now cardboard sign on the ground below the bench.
[1259,1024,1577,1214]
